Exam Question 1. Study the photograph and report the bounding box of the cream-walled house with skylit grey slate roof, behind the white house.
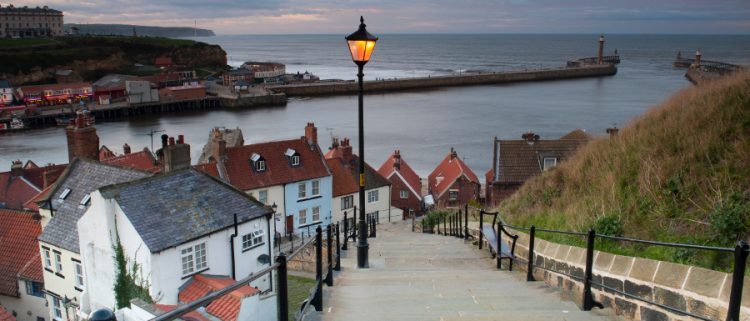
[37,158,152,320]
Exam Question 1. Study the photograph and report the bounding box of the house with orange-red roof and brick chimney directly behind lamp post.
[325,138,391,222]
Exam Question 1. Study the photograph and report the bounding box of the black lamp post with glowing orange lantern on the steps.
[346,17,378,269]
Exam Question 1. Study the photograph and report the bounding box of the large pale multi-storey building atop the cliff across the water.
[0,5,63,38]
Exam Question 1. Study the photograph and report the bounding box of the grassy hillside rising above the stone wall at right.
[501,73,750,269]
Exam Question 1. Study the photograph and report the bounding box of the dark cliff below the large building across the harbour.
[0,36,227,86]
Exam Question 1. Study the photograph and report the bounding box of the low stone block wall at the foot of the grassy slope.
[470,225,750,321]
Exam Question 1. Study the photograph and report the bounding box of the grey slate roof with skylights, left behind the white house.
[38,159,152,253]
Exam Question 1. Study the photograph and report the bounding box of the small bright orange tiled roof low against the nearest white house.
[178,274,258,321]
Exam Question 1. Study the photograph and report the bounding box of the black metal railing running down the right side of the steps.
[426,206,750,321]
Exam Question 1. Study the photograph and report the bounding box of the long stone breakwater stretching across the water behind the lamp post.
[268,64,617,97]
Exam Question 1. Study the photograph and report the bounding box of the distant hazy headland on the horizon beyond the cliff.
[64,23,216,38]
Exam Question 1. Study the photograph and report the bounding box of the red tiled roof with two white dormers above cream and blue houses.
[212,138,330,190]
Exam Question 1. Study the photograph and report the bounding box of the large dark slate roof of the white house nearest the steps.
[99,169,273,253]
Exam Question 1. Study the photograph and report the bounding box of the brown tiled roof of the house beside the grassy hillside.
[486,130,590,184]
